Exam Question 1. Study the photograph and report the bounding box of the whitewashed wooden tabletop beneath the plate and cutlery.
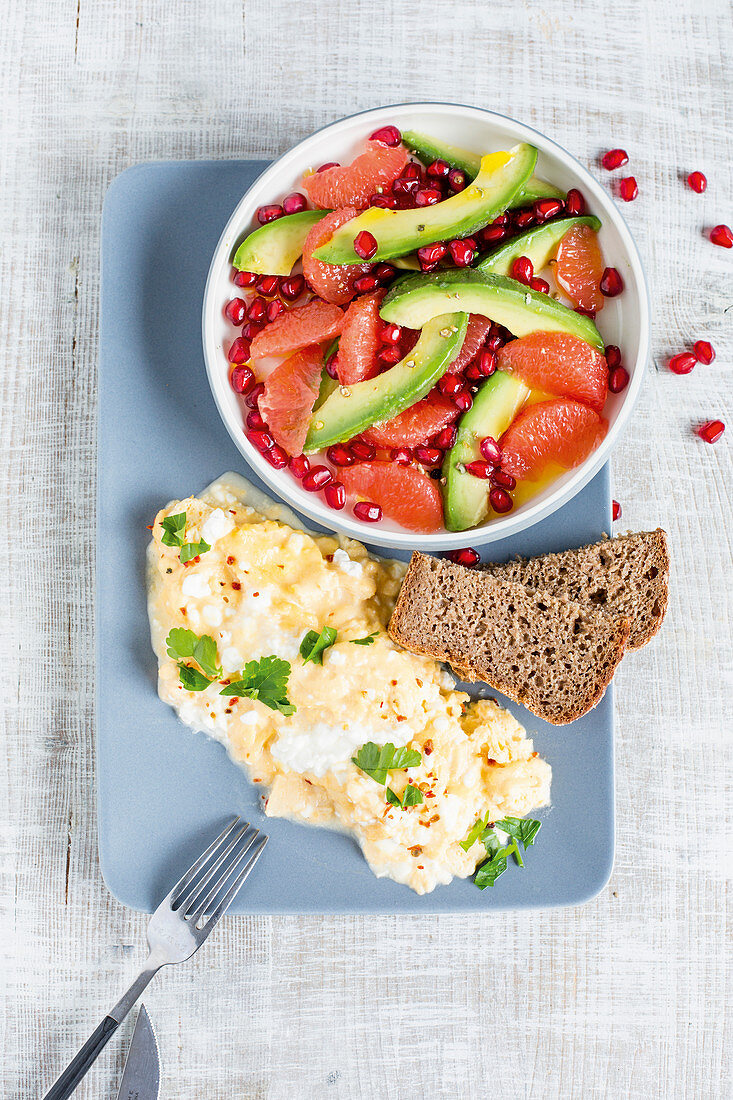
[0,0,733,1100]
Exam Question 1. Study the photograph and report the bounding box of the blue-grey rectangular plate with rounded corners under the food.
[97,161,613,913]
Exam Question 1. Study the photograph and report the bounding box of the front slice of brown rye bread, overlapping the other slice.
[390,552,630,725]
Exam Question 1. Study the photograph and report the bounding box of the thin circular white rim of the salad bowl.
[201,100,652,551]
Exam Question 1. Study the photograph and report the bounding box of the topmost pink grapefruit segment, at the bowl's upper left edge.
[303,141,408,210]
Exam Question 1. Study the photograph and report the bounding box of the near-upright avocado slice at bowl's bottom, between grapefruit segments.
[435,371,529,531]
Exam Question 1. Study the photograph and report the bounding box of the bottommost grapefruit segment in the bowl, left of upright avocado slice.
[339,459,442,531]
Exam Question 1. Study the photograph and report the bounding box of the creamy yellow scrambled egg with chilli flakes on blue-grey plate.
[149,474,550,893]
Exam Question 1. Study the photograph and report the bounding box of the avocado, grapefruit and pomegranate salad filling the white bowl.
[225,125,628,532]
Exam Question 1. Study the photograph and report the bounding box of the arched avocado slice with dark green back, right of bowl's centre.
[380,267,604,354]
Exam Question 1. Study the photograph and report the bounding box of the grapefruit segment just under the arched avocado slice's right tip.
[497,332,609,413]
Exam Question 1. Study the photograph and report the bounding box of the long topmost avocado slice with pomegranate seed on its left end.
[314,145,537,264]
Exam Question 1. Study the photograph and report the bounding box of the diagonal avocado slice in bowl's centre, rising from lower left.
[303,314,468,454]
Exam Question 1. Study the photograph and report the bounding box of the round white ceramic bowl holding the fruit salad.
[203,103,650,551]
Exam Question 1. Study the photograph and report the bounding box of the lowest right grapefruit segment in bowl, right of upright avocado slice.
[501,397,609,481]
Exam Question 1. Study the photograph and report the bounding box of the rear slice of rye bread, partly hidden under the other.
[481,527,669,650]
